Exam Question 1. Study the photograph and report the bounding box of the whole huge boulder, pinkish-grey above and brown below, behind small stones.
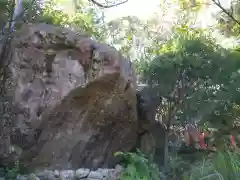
[0,24,157,169]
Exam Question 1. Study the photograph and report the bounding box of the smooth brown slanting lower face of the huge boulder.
[21,73,138,172]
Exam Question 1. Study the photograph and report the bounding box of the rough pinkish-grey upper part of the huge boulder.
[9,24,136,137]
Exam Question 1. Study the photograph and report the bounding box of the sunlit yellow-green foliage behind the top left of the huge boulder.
[0,0,105,41]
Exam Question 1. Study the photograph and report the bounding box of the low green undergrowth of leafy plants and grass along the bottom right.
[115,151,240,180]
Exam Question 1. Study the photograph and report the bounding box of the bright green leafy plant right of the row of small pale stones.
[115,151,161,180]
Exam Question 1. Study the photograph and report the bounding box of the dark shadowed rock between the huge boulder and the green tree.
[138,86,167,166]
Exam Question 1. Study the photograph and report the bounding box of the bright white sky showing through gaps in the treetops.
[59,0,234,46]
